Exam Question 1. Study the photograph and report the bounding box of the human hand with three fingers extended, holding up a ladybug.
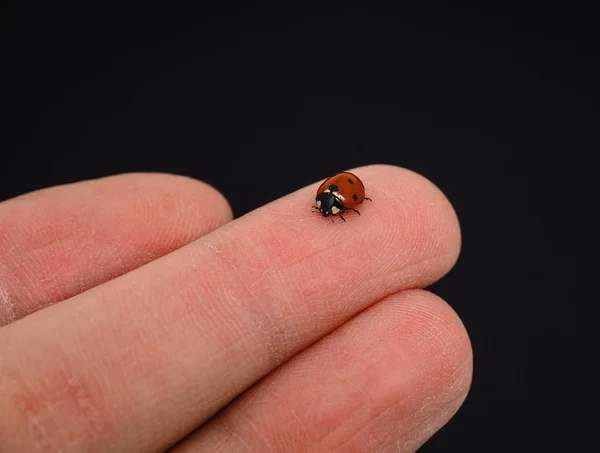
[0,165,472,453]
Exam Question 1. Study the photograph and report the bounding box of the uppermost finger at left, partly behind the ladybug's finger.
[0,174,232,326]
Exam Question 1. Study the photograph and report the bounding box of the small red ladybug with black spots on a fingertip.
[313,171,373,222]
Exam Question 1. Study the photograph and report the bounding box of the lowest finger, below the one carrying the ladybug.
[171,290,472,453]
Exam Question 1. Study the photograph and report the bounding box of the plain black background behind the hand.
[0,2,584,452]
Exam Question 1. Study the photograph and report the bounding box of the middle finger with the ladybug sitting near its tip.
[0,165,460,453]
